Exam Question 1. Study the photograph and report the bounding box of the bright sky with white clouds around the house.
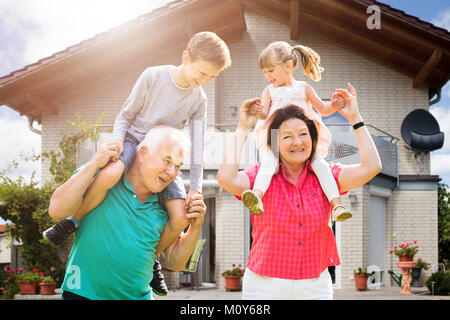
[0,0,450,189]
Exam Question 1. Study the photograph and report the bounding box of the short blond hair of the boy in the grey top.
[186,31,231,69]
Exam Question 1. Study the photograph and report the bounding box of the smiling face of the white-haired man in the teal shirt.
[138,139,183,193]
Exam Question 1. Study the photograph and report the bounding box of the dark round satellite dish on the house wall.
[401,109,444,152]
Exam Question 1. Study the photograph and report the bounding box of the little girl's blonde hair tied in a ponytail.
[258,41,324,81]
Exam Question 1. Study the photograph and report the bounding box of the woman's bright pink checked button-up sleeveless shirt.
[236,161,343,280]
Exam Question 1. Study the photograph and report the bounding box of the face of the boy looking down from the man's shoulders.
[183,52,223,88]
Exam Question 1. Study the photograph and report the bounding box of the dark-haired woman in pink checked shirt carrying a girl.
[217,84,381,300]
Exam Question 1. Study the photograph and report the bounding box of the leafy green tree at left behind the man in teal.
[0,115,103,284]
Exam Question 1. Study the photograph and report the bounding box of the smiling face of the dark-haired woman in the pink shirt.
[278,118,312,165]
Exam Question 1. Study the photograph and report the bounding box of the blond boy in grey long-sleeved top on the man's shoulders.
[43,32,231,295]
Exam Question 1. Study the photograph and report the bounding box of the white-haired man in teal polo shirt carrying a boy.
[49,127,206,300]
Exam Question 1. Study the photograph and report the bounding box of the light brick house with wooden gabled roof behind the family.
[0,0,450,288]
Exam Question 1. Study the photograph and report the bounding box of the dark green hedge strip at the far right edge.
[438,183,450,261]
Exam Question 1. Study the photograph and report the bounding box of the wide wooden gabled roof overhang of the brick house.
[0,0,450,122]
